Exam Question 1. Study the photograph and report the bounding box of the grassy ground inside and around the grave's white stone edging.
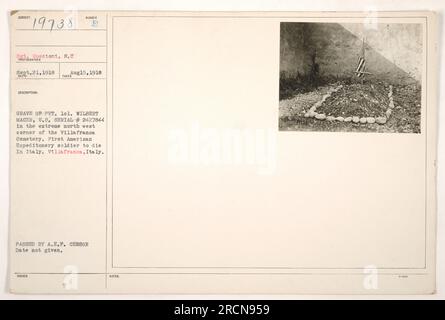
[279,83,421,133]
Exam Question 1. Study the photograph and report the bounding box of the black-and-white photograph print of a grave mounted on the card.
[279,22,423,133]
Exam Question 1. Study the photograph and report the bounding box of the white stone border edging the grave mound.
[304,85,395,124]
